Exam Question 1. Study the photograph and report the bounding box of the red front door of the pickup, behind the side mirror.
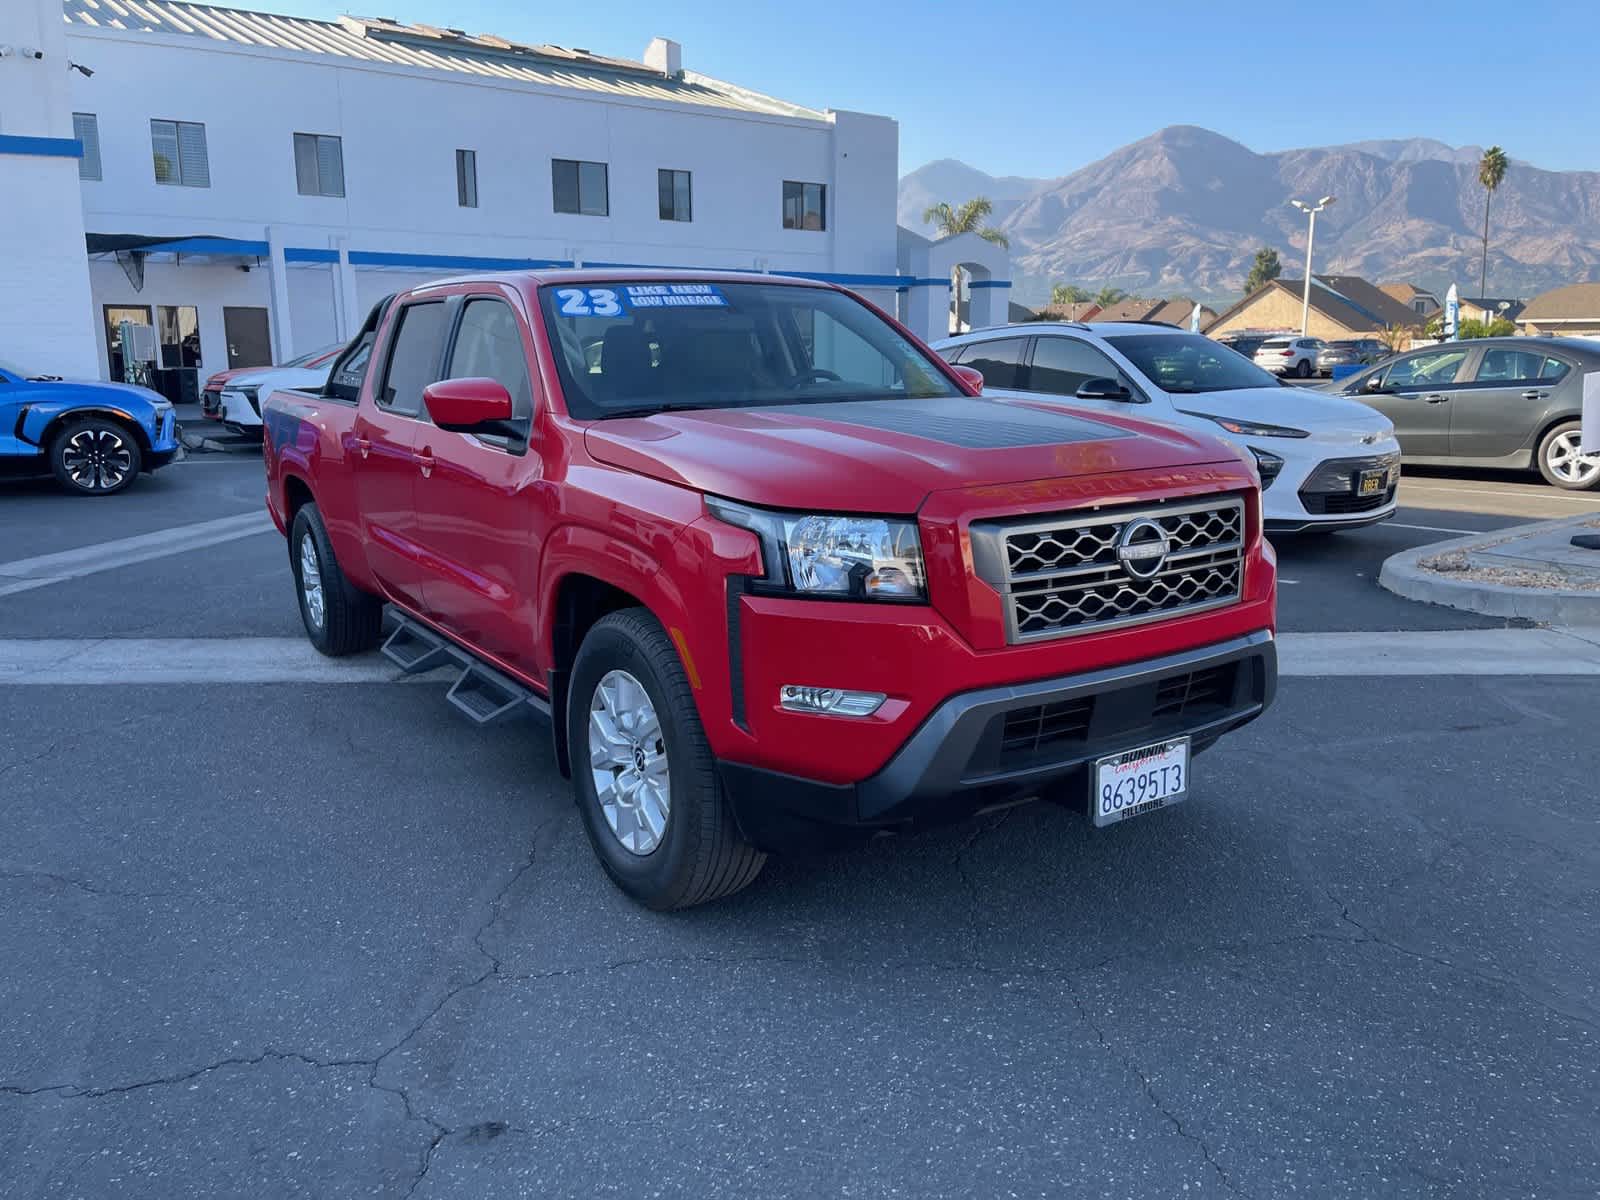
[406,296,546,677]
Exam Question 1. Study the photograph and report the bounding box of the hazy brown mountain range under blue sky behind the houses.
[899,125,1600,306]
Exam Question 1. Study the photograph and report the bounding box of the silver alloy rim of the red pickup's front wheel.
[589,670,672,856]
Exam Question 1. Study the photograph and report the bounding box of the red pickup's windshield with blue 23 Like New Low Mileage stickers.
[539,282,962,419]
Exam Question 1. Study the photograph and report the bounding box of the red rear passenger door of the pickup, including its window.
[349,301,445,611]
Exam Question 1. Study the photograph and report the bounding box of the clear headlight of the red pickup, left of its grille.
[706,496,928,600]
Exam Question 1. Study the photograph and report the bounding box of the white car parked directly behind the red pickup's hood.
[934,322,1400,533]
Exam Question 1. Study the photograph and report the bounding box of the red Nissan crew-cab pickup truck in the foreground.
[264,270,1277,907]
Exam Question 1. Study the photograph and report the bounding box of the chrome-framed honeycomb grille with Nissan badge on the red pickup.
[973,496,1245,643]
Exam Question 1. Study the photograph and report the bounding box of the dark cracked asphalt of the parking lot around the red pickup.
[0,454,1600,1198]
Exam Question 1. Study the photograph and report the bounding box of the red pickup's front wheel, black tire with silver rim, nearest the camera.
[566,608,766,910]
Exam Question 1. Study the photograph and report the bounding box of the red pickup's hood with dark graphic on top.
[584,397,1237,514]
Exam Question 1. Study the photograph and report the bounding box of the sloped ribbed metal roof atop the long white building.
[62,0,826,120]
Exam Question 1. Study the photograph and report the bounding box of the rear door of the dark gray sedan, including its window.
[1450,346,1573,458]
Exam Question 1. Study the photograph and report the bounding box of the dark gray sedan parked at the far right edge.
[1326,338,1600,491]
